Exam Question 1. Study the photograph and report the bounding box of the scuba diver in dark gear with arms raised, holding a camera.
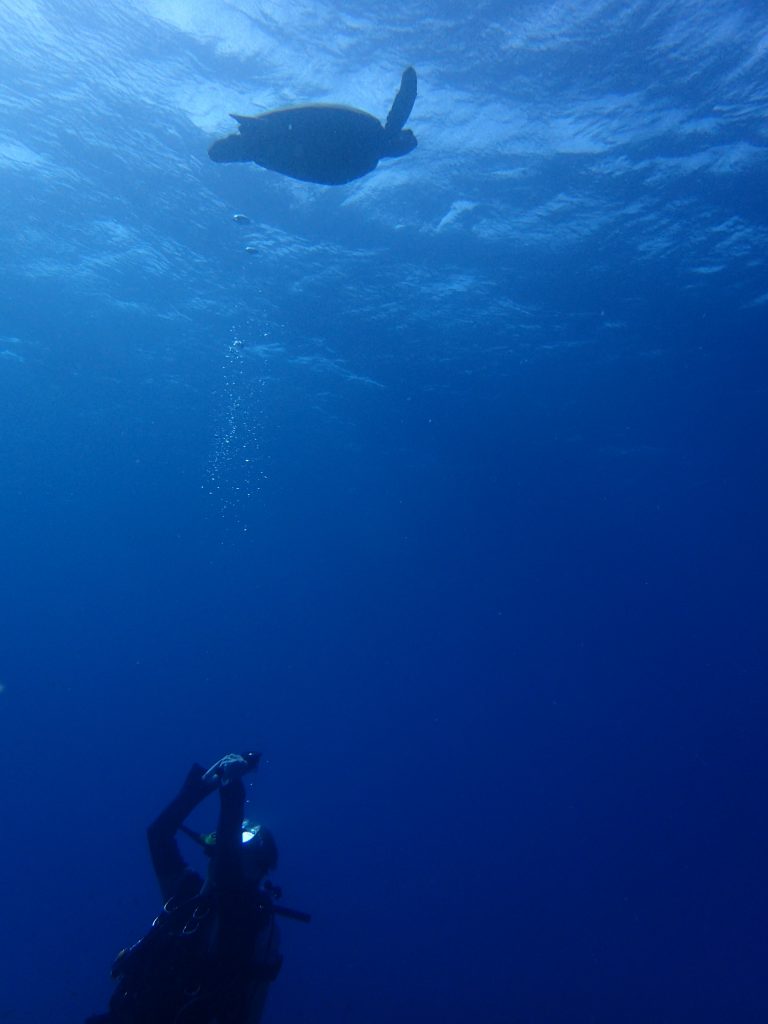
[86,754,309,1024]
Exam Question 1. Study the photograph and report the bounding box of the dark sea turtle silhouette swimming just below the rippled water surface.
[208,68,416,185]
